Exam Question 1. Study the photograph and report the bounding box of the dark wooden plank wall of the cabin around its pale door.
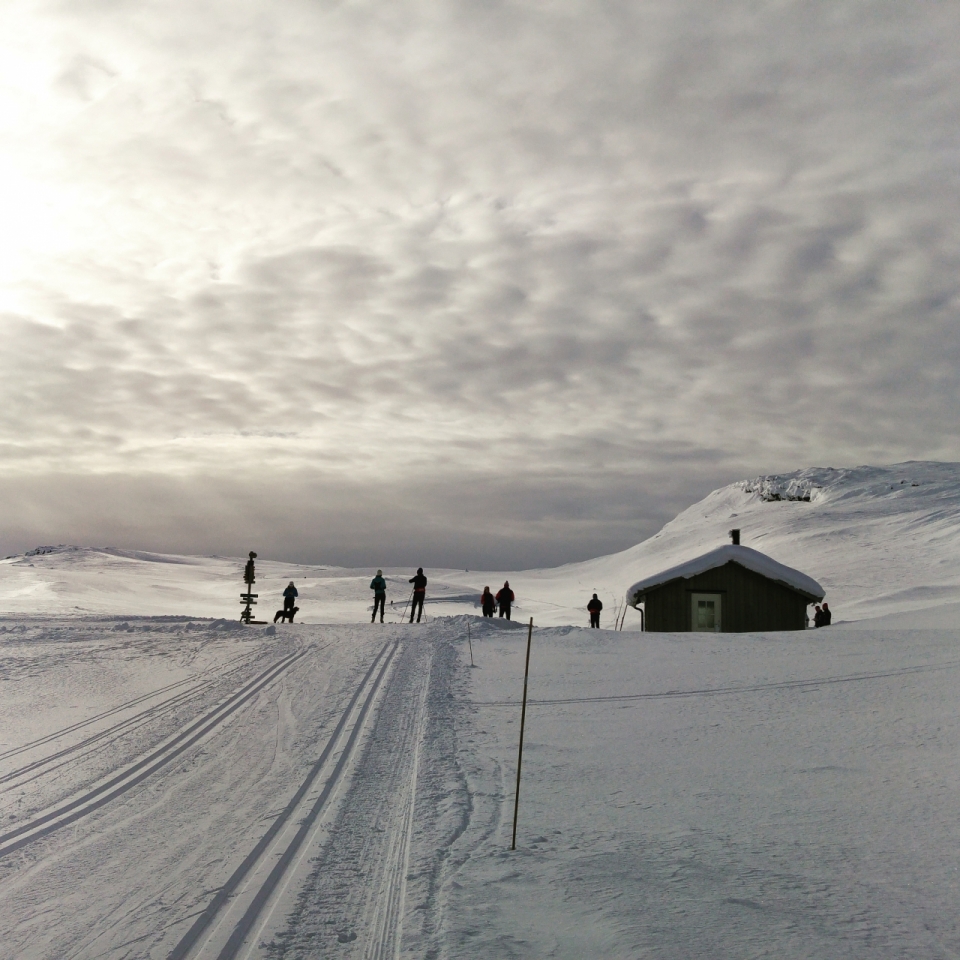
[644,560,809,633]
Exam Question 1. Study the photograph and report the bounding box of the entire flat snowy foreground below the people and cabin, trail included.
[0,617,960,960]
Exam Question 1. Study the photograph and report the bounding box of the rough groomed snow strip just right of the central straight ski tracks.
[251,631,457,960]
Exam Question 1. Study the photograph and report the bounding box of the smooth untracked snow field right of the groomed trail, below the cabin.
[443,629,960,960]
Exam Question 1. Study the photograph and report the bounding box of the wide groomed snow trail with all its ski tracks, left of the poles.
[0,621,468,960]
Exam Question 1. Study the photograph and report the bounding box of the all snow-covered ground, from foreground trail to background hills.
[0,464,960,960]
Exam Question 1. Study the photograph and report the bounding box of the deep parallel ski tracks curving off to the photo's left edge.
[0,649,308,858]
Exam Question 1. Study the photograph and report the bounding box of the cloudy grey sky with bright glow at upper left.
[0,0,960,569]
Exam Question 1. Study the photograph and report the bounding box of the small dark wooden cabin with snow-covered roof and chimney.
[627,531,824,633]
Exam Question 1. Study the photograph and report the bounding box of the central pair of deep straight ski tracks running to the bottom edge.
[168,640,405,960]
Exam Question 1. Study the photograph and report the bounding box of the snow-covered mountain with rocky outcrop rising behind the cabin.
[557,462,960,626]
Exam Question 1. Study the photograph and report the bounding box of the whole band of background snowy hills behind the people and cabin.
[0,462,960,630]
